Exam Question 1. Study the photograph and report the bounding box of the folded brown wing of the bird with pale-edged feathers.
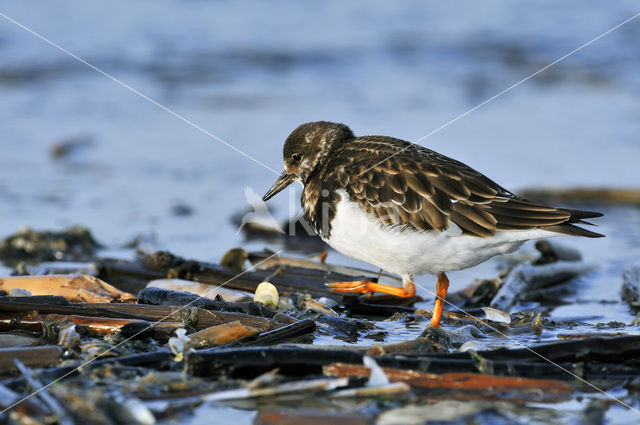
[334,138,580,237]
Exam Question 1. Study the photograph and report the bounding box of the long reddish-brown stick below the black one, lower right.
[323,363,572,402]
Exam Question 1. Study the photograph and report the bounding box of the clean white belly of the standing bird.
[326,190,556,277]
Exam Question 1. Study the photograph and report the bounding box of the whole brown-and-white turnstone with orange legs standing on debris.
[263,121,603,327]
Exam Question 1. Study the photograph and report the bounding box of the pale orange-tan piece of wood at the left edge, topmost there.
[0,275,135,303]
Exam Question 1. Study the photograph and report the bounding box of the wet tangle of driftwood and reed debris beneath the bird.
[0,224,640,425]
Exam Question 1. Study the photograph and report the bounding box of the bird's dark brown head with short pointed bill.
[262,121,354,201]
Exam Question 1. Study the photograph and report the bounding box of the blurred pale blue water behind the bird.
[0,1,640,260]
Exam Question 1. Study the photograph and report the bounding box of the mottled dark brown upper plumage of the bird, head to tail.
[268,122,602,237]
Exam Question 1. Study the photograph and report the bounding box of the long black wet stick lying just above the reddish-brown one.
[189,336,640,380]
